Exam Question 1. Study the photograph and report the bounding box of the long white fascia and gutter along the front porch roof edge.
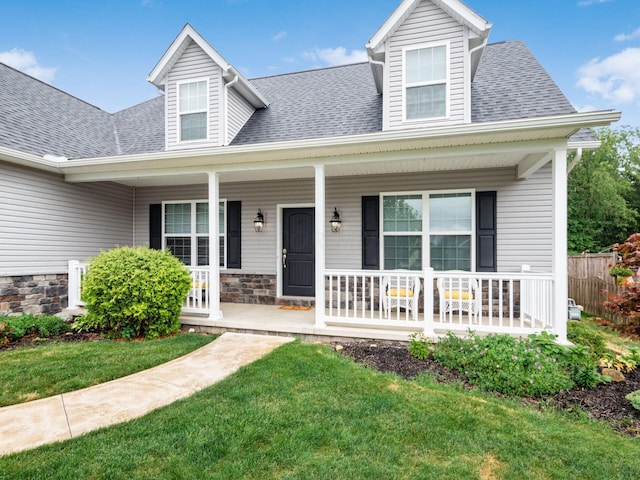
[59,110,621,178]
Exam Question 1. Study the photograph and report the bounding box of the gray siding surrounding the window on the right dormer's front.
[384,0,467,128]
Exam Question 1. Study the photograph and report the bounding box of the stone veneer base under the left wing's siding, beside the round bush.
[0,274,68,314]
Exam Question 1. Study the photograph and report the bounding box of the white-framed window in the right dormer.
[403,44,449,120]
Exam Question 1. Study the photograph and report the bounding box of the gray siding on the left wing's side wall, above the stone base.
[0,162,133,275]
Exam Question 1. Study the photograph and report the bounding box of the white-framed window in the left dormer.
[178,80,209,142]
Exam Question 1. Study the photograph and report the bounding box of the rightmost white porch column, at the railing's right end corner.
[551,149,569,343]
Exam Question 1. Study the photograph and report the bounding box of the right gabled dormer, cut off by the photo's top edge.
[367,0,492,130]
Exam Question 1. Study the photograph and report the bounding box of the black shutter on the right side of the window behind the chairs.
[476,192,498,272]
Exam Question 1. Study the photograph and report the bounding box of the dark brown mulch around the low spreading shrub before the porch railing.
[333,342,640,437]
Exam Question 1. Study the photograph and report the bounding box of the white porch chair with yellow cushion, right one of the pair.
[437,271,482,323]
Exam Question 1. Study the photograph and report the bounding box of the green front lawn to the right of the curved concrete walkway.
[0,342,640,480]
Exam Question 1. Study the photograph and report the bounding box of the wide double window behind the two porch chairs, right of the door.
[382,191,474,271]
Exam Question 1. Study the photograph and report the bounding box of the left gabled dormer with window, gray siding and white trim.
[147,24,268,150]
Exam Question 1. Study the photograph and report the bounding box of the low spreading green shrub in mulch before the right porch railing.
[433,332,606,397]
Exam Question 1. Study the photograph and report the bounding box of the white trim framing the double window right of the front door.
[379,188,476,272]
